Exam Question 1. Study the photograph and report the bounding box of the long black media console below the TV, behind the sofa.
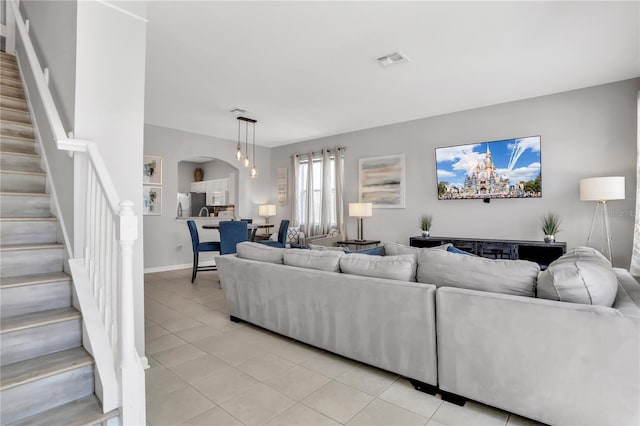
[409,237,567,269]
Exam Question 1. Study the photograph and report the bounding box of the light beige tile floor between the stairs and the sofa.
[145,269,537,426]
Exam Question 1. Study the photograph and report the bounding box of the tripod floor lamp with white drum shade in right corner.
[580,176,624,264]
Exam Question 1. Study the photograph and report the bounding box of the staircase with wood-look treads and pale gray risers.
[0,52,120,425]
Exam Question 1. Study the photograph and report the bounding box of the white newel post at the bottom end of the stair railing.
[118,201,146,425]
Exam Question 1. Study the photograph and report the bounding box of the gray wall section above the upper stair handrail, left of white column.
[20,0,78,132]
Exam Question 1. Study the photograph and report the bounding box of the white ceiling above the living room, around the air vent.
[145,1,640,146]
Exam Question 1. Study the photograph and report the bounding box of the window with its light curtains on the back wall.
[293,148,344,236]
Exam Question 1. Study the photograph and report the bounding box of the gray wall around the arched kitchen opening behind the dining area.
[144,124,273,272]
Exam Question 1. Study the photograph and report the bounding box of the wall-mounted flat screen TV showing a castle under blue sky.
[436,136,542,200]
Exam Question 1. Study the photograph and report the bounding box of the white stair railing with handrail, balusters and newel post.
[3,0,146,425]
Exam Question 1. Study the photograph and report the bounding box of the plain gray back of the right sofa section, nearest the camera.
[436,287,640,425]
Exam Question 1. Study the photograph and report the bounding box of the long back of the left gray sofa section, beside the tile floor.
[216,255,437,387]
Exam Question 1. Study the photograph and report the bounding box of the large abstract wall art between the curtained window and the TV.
[358,154,406,209]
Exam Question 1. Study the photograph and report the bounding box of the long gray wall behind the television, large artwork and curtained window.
[270,79,640,268]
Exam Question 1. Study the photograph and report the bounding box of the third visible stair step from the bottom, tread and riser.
[0,307,82,366]
